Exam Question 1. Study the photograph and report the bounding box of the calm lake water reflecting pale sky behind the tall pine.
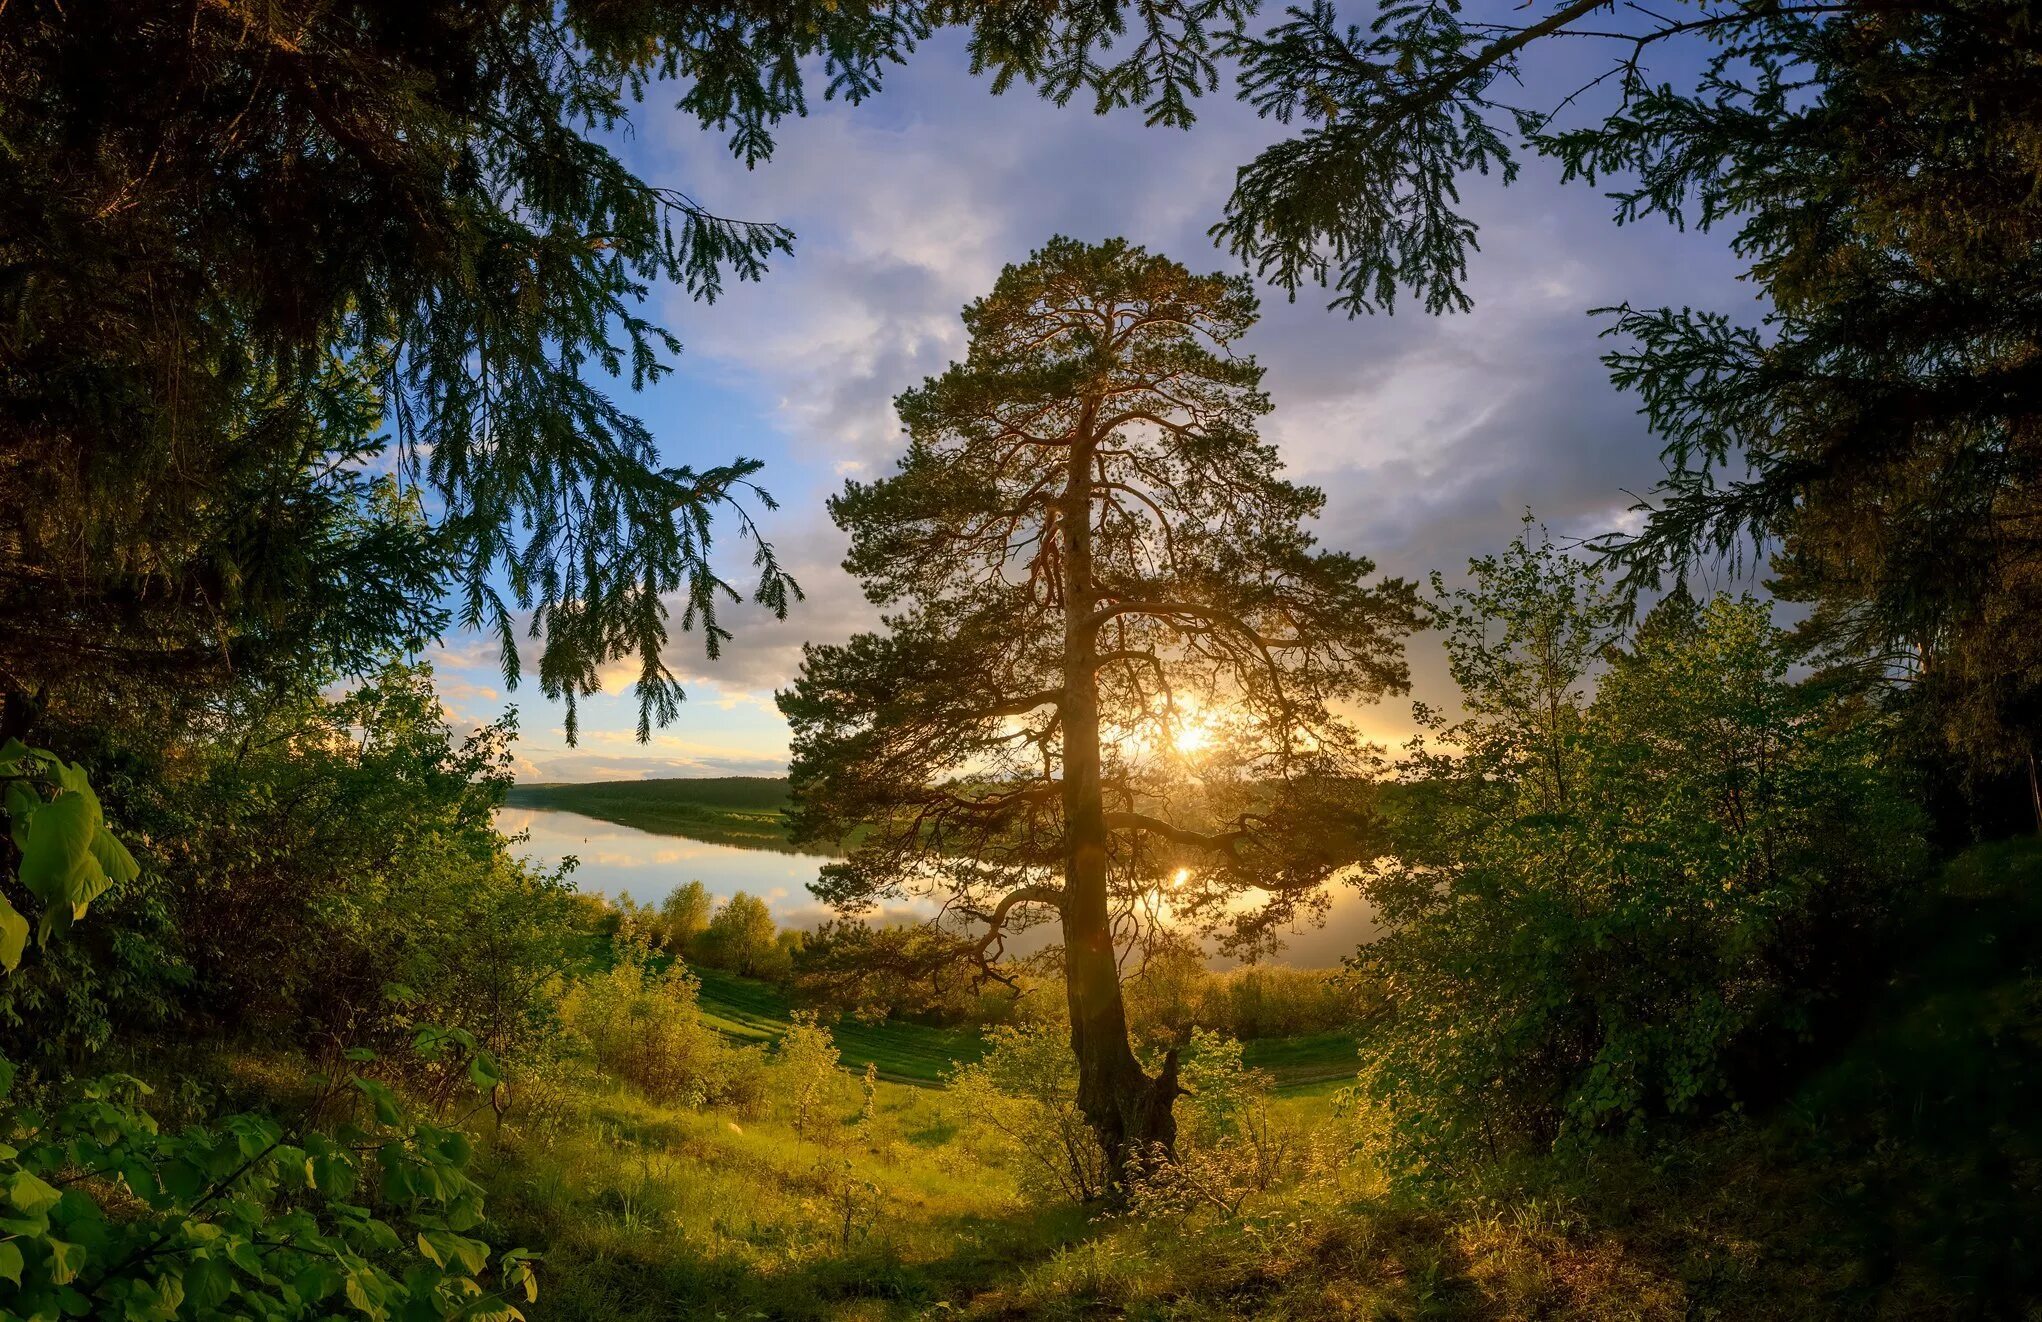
[496,807,1376,969]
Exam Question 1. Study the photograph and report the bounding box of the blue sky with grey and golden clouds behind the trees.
[431,23,1758,781]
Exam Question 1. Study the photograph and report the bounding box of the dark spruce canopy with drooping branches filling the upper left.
[0,0,1246,734]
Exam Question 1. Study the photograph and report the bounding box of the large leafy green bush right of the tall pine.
[1358,529,1924,1171]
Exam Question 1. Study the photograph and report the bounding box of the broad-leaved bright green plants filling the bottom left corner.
[0,1052,537,1320]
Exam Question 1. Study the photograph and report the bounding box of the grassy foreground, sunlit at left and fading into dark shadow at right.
[488,842,2042,1322]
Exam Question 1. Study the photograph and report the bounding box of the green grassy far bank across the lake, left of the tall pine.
[506,776,831,854]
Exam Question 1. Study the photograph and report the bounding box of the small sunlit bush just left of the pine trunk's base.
[950,1024,1107,1203]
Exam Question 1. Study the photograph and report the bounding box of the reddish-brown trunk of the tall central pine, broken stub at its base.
[1062,411,1180,1195]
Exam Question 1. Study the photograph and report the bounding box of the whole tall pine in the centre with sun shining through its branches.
[780,239,1413,1167]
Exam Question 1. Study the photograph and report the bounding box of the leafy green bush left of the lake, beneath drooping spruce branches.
[78,666,572,1058]
